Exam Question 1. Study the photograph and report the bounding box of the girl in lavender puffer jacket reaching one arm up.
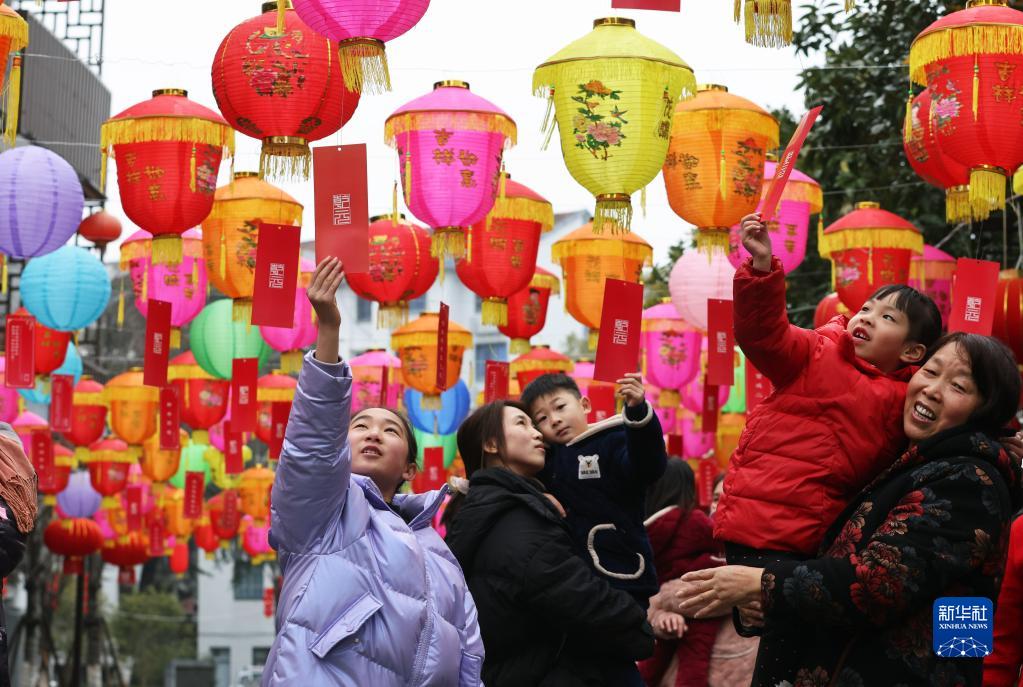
[263,258,483,687]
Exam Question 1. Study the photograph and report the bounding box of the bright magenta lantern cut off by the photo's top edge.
[295,0,430,92]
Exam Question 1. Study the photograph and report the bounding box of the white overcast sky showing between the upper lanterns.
[97,0,803,263]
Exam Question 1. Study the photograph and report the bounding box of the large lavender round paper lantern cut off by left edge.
[0,147,85,258]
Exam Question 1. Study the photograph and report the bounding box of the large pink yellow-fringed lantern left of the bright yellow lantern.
[384,81,516,259]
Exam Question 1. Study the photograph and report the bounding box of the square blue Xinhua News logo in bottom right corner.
[934,596,994,658]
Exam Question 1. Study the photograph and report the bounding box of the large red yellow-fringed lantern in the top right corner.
[909,0,1023,215]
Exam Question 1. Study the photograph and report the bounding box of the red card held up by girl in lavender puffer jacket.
[317,143,369,273]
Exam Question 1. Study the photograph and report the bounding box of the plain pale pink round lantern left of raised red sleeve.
[668,250,736,331]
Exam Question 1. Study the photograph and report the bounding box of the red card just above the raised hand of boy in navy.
[593,279,642,382]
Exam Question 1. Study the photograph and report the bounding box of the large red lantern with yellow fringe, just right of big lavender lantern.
[99,88,234,265]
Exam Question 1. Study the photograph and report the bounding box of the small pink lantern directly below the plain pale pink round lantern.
[640,302,703,408]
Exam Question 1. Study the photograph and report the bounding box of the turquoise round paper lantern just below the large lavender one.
[20,245,110,331]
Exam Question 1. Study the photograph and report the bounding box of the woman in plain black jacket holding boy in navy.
[447,401,654,687]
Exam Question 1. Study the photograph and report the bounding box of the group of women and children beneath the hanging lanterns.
[253,215,1023,687]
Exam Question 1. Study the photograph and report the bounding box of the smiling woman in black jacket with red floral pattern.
[680,333,1020,687]
